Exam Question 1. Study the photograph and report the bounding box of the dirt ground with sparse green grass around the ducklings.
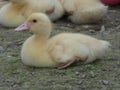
[0,6,120,90]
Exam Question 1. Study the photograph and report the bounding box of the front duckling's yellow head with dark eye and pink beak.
[15,13,52,36]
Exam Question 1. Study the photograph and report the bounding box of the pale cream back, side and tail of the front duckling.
[49,33,110,63]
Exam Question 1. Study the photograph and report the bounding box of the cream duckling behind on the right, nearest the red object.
[60,0,108,24]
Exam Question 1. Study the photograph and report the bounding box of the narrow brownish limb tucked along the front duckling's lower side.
[57,56,88,69]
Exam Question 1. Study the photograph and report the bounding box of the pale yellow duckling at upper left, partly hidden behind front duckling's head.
[0,0,64,27]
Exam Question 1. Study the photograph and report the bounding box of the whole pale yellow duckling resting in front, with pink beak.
[15,13,110,69]
